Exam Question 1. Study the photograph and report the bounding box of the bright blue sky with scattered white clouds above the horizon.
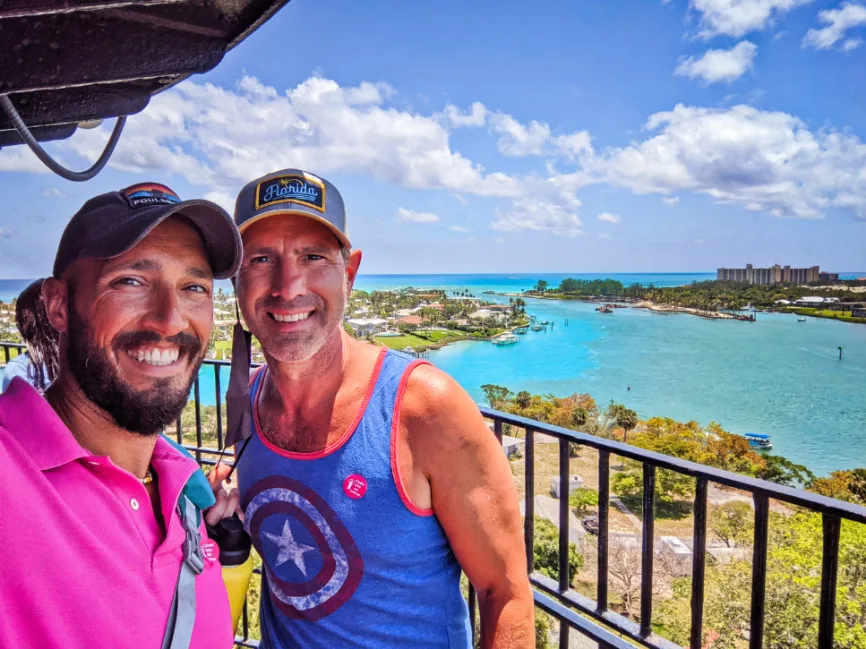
[0,0,866,278]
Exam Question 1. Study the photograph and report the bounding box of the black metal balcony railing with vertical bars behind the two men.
[0,343,866,649]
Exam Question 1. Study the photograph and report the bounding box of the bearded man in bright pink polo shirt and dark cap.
[0,183,241,649]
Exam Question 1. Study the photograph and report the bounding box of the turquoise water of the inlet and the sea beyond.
[0,273,866,474]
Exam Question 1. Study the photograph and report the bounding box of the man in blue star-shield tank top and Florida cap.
[211,169,535,649]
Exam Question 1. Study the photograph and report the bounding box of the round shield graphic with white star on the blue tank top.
[244,476,364,621]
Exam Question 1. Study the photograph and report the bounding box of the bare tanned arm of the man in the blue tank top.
[400,365,535,649]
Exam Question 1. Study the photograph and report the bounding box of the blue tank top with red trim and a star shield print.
[238,350,471,649]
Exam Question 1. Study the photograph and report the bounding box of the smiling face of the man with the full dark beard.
[49,217,213,435]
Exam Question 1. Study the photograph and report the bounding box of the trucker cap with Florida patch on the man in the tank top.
[235,169,352,248]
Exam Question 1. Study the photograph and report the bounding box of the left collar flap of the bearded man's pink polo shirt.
[0,377,90,471]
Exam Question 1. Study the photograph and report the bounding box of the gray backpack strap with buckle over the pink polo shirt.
[162,495,204,649]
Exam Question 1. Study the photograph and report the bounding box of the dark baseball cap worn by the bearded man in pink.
[54,183,243,279]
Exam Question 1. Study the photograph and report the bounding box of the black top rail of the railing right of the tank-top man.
[480,406,866,523]
